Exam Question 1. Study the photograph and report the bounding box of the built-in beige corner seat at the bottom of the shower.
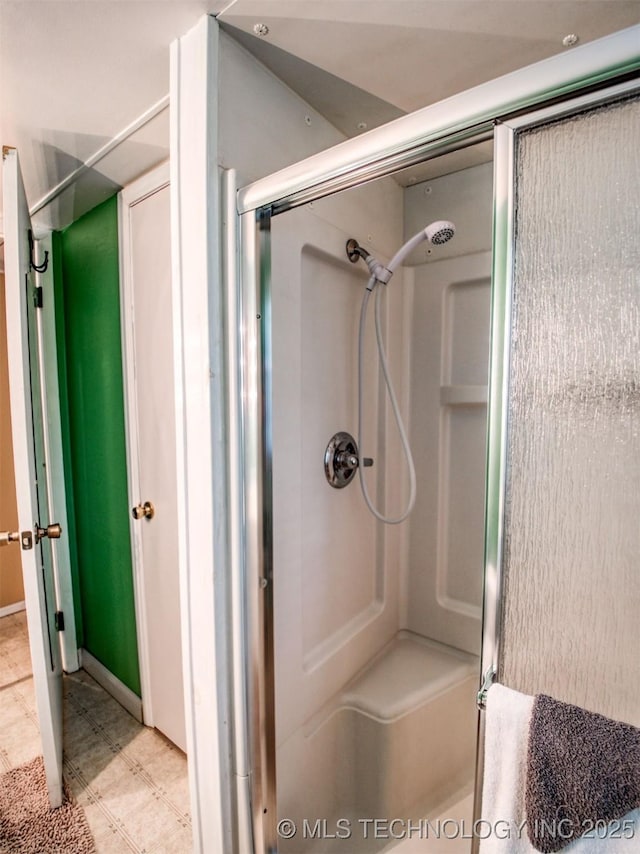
[278,631,479,854]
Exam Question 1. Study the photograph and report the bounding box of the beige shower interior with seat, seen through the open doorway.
[269,157,492,852]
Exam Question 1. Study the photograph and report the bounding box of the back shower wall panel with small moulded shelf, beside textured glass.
[405,252,491,654]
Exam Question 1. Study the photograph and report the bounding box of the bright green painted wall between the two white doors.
[53,196,140,696]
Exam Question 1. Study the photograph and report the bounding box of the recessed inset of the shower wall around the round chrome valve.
[298,247,384,656]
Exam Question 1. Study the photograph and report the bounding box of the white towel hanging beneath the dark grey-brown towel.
[476,684,640,854]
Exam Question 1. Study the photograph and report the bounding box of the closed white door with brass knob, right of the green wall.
[120,166,186,751]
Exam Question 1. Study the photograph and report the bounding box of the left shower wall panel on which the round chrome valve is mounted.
[271,181,406,745]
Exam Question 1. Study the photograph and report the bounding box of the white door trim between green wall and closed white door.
[118,161,169,726]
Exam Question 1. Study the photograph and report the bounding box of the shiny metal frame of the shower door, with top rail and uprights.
[234,27,640,854]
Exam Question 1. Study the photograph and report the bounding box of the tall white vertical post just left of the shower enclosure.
[170,16,235,854]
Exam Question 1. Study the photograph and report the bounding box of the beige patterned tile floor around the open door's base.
[0,612,192,854]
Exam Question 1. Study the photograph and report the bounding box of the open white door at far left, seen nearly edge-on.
[0,148,62,807]
